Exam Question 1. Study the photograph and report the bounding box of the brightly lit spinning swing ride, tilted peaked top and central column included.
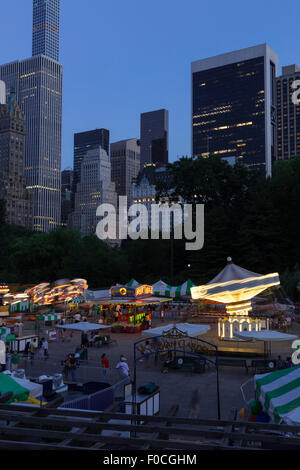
[191,258,280,340]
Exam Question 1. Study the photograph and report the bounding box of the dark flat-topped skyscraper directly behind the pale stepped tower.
[73,129,109,188]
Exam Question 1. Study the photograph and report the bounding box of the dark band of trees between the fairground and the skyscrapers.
[0,157,300,299]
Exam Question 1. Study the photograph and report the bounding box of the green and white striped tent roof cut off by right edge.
[254,366,300,425]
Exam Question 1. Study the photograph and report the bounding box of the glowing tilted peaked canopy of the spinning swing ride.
[191,258,280,304]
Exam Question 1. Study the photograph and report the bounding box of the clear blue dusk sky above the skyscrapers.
[0,0,300,169]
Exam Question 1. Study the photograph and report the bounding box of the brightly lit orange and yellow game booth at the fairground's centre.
[94,284,172,333]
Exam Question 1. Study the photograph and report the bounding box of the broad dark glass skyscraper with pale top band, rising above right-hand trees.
[191,44,278,175]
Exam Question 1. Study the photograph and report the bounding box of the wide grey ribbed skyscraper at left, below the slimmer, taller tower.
[0,0,62,232]
